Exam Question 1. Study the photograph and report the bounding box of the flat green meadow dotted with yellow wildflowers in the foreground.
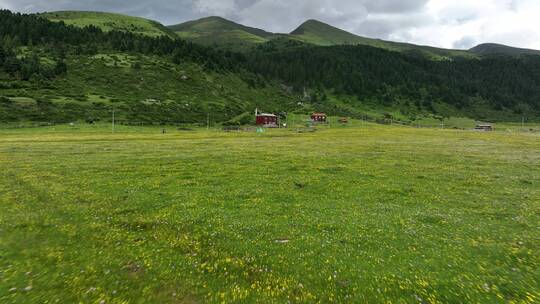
[0,121,540,303]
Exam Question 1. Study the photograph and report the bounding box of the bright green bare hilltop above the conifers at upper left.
[39,11,176,38]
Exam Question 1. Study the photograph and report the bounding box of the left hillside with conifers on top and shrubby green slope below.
[0,11,295,123]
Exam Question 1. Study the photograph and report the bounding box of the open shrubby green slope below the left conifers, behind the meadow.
[0,49,294,123]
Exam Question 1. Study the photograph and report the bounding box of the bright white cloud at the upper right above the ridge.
[416,0,540,48]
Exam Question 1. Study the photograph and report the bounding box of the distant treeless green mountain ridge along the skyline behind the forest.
[38,11,540,60]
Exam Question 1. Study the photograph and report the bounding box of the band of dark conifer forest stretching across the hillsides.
[0,10,540,117]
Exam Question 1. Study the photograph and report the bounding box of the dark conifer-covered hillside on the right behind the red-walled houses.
[248,45,540,119]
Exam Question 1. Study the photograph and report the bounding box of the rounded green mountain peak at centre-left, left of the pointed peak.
[168,17,275,50]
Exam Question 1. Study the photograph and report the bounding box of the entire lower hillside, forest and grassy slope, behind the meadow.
[0,11,540,123]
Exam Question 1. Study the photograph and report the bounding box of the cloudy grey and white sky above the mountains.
[0,0,540,49]
